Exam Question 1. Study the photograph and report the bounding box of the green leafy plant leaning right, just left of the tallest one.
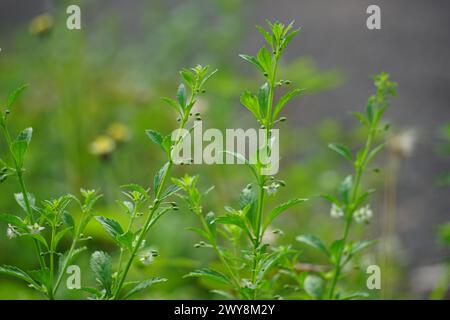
[89,65,216,299]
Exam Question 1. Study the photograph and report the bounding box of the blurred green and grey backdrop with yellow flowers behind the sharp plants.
[0,0,450,299]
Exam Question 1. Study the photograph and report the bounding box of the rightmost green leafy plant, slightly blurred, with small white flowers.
[297,72,397,299]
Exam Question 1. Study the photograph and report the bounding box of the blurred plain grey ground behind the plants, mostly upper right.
[0,0,450,284]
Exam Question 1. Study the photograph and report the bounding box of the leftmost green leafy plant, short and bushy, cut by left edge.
[0,85,101,299]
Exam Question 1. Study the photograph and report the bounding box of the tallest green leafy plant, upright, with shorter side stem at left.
[175,22,306,299]
